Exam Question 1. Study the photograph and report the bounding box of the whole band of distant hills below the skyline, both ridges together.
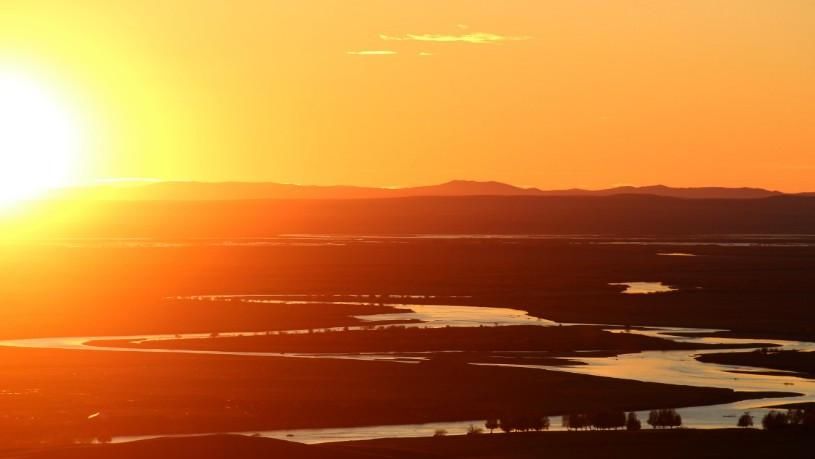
[17,180,815,239]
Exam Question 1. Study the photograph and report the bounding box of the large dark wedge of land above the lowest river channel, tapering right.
[0,348,784,447]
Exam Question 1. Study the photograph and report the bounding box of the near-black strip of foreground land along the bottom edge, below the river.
[0,429,813,459]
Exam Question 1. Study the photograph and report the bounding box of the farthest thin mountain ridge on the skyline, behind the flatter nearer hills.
[56,180,804,201]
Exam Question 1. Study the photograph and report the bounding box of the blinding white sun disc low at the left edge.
[0,69,79,208]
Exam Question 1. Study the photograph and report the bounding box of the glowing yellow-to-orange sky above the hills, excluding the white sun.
[0,0,815,191]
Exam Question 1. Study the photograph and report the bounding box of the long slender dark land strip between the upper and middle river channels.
[87,324,760,357]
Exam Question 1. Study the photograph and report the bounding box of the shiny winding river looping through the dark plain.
[0,295,815,443]
